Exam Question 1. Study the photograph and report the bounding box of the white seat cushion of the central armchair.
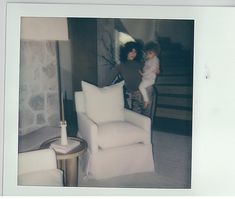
[98,121,149,149]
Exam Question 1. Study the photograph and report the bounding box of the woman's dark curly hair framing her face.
[119,41,143,63]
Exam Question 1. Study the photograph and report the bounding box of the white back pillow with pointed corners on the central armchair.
[82,81,124,124]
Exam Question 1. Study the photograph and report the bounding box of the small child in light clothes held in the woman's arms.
[139,42,160,108]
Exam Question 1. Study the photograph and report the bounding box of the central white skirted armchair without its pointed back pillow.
[75,92,154,179]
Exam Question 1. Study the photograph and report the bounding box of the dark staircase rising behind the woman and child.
[156,37,193,134]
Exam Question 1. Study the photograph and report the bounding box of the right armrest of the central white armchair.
[124,109,151,134]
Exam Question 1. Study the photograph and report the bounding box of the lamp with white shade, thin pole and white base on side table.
[21,17,69,145]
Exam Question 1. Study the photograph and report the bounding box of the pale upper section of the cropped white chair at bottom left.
[18,149,57,175]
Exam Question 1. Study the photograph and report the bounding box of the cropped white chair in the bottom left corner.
[18,149,63,186]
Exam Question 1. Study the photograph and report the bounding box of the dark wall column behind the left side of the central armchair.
[68,18,97,91]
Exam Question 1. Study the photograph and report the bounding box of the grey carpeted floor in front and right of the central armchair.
[79,131,192,189]
